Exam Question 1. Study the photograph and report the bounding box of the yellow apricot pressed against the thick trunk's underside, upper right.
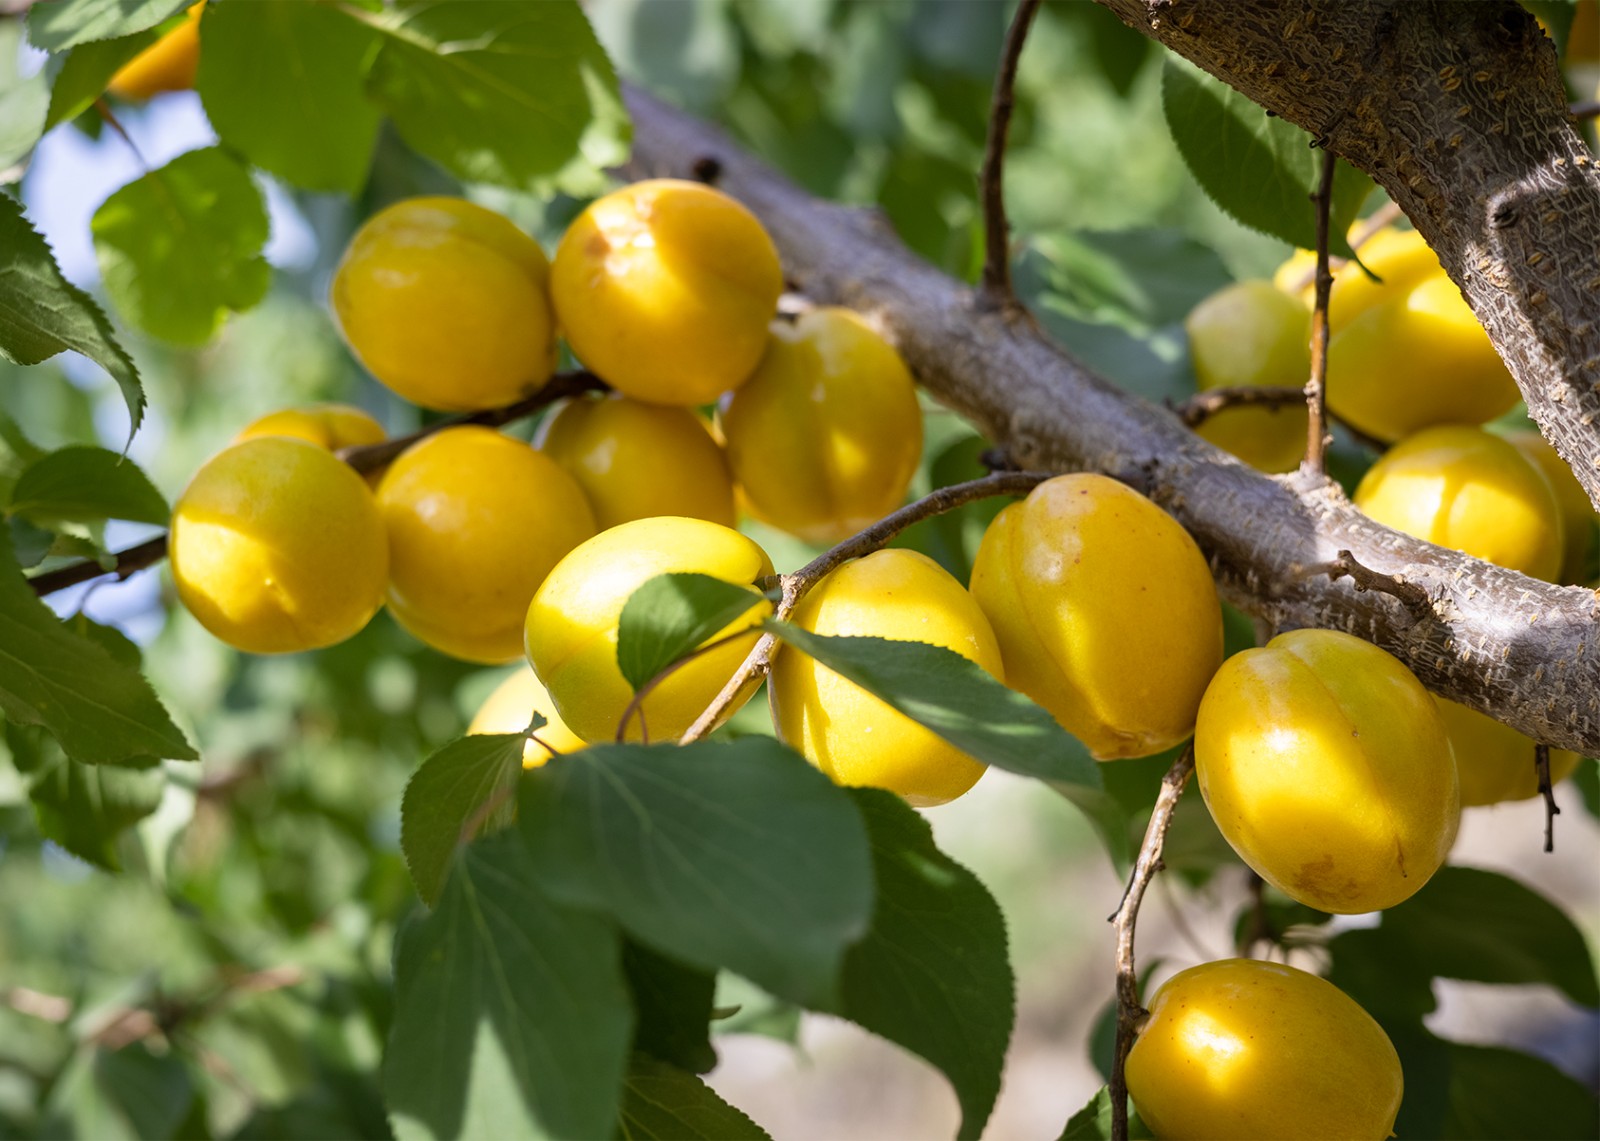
[1328,230,1520,440]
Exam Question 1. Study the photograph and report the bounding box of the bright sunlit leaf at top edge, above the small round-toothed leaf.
[195,3,381,194]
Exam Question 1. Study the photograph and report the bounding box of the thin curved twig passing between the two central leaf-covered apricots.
[678,472,1053,744]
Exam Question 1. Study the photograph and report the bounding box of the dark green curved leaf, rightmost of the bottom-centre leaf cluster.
[835,789,1016,1138]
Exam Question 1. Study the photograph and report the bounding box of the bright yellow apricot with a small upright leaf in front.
[526,515,773,741]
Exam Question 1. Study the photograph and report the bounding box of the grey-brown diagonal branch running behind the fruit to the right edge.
[627,91,1600,754]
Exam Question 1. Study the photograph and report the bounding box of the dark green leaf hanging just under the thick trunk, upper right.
[1162,54,1373,258]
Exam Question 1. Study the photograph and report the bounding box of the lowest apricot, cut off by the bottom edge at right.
[1128,959,1405,1141]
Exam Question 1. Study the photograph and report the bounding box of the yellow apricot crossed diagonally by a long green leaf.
[768,549,1005,807]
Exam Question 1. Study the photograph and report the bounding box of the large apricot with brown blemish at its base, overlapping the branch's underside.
[1195,631,1461,914]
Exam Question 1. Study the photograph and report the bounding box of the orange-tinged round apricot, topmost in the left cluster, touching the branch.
[550,179,784,405]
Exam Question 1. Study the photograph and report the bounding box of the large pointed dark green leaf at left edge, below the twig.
[0,530,197,765]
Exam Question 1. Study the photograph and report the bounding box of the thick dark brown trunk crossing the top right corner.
[1099,0,1600,507]
